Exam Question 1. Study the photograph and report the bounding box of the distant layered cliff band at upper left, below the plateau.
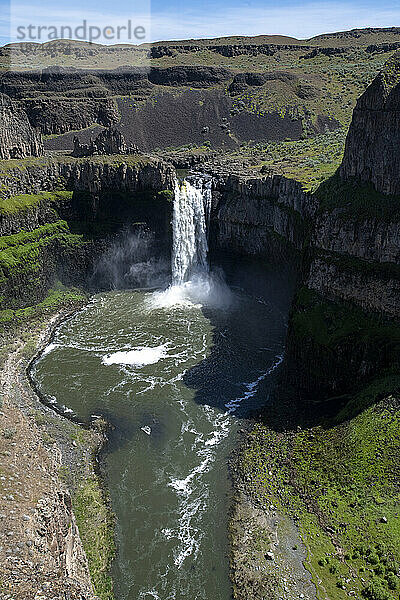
[0,66,232,135]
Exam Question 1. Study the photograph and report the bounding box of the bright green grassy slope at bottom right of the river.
[241,392,400,600]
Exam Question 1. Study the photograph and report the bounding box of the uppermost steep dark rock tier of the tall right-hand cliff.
[340,52,400,195]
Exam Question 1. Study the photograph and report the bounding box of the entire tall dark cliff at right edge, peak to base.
[285,53,400,401]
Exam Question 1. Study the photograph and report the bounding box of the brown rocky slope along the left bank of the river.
[0,313,112,600]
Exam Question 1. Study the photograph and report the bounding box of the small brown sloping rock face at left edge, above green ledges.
[0,94,44,159]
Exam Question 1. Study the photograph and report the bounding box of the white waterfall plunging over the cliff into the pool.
[172,177,211,285]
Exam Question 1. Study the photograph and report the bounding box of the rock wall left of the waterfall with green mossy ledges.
[0,156,175,309]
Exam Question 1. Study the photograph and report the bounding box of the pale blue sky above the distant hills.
[0,0,400,44]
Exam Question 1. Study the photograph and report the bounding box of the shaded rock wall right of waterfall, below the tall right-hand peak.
[205,164,400,401]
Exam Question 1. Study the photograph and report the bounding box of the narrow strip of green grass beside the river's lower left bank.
[72,475,115,600]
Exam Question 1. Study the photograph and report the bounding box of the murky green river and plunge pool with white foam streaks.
[32,264,290,600]
